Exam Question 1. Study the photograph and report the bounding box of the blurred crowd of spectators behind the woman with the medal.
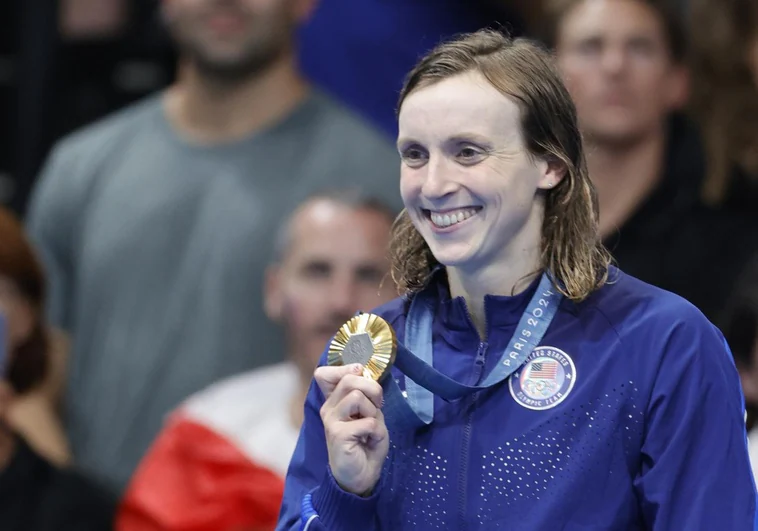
[0,0,758,531]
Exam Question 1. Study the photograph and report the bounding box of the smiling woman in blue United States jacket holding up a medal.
[278,31,756,531]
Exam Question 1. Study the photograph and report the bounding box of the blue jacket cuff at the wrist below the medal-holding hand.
[311,467,384,531]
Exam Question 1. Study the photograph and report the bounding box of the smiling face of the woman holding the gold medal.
[398,73,560,271]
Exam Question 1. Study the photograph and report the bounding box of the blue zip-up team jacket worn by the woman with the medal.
[277,269,758,531]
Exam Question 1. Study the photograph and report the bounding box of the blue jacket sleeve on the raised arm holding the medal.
[276,358,382,531]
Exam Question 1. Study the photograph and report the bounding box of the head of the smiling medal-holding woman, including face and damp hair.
[392,40,610,324]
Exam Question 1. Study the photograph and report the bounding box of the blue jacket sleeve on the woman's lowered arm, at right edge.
[635,310,758,531]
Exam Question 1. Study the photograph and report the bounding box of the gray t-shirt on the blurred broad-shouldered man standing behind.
[28,92,401,490]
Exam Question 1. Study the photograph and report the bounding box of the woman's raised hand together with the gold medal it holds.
[315,314,397,495]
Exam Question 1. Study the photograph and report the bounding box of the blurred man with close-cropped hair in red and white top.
[117,192,397,531]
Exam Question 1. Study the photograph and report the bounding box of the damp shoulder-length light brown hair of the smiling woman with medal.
[390,30,611,301]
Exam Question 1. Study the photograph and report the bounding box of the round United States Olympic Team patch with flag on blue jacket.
[508,347,576,411]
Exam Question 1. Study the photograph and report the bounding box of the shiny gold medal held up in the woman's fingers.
[327,313,397,382]
